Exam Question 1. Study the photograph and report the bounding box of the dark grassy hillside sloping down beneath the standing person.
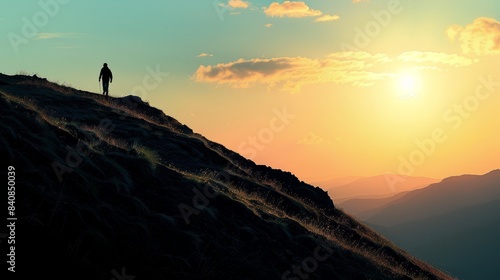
[0,75,450,280]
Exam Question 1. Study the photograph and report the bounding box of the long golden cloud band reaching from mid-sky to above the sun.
[192,51,478,93]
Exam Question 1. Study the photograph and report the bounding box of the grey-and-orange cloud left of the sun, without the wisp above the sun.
[193,52,391,92]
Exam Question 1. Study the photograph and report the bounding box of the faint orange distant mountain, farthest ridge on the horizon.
[320,174,439,202]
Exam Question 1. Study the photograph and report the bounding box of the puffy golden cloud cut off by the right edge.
[446,17,500,55]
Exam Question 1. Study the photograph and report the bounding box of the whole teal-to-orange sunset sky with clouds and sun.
[0,0,500,181]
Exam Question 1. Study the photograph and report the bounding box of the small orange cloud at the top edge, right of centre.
[264,1,323,18]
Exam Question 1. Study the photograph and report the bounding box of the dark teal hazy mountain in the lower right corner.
[358,170,500,279]
